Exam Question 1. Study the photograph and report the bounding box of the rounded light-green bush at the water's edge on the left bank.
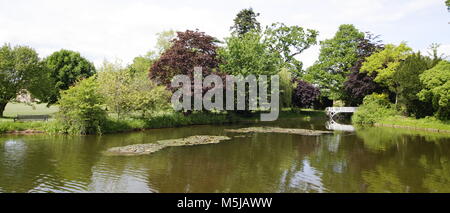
[56,77,107,135]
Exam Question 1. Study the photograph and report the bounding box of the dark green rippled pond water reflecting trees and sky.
[0,119,450,192]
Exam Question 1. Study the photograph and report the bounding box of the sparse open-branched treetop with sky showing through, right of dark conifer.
[264,23,319,76]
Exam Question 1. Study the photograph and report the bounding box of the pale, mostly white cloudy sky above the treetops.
[0,0,450,67]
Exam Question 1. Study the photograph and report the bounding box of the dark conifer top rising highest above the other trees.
[231,8,261,35]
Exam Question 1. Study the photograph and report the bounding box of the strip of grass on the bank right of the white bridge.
[377,116,450,131]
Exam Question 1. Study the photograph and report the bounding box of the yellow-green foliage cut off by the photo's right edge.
[418,60,450,120]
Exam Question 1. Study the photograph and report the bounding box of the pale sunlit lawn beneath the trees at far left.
[3,103,58,117]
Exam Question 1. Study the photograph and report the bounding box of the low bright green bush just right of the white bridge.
[352,93,396,124]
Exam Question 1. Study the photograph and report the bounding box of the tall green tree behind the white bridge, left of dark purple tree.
[305,24,364,100]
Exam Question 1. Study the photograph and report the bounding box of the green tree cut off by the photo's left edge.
[0,44,44,117]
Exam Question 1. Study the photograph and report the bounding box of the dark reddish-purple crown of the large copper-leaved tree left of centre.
[149,30,219,86]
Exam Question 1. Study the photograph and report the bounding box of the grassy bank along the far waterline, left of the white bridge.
[0,109,326,134]
